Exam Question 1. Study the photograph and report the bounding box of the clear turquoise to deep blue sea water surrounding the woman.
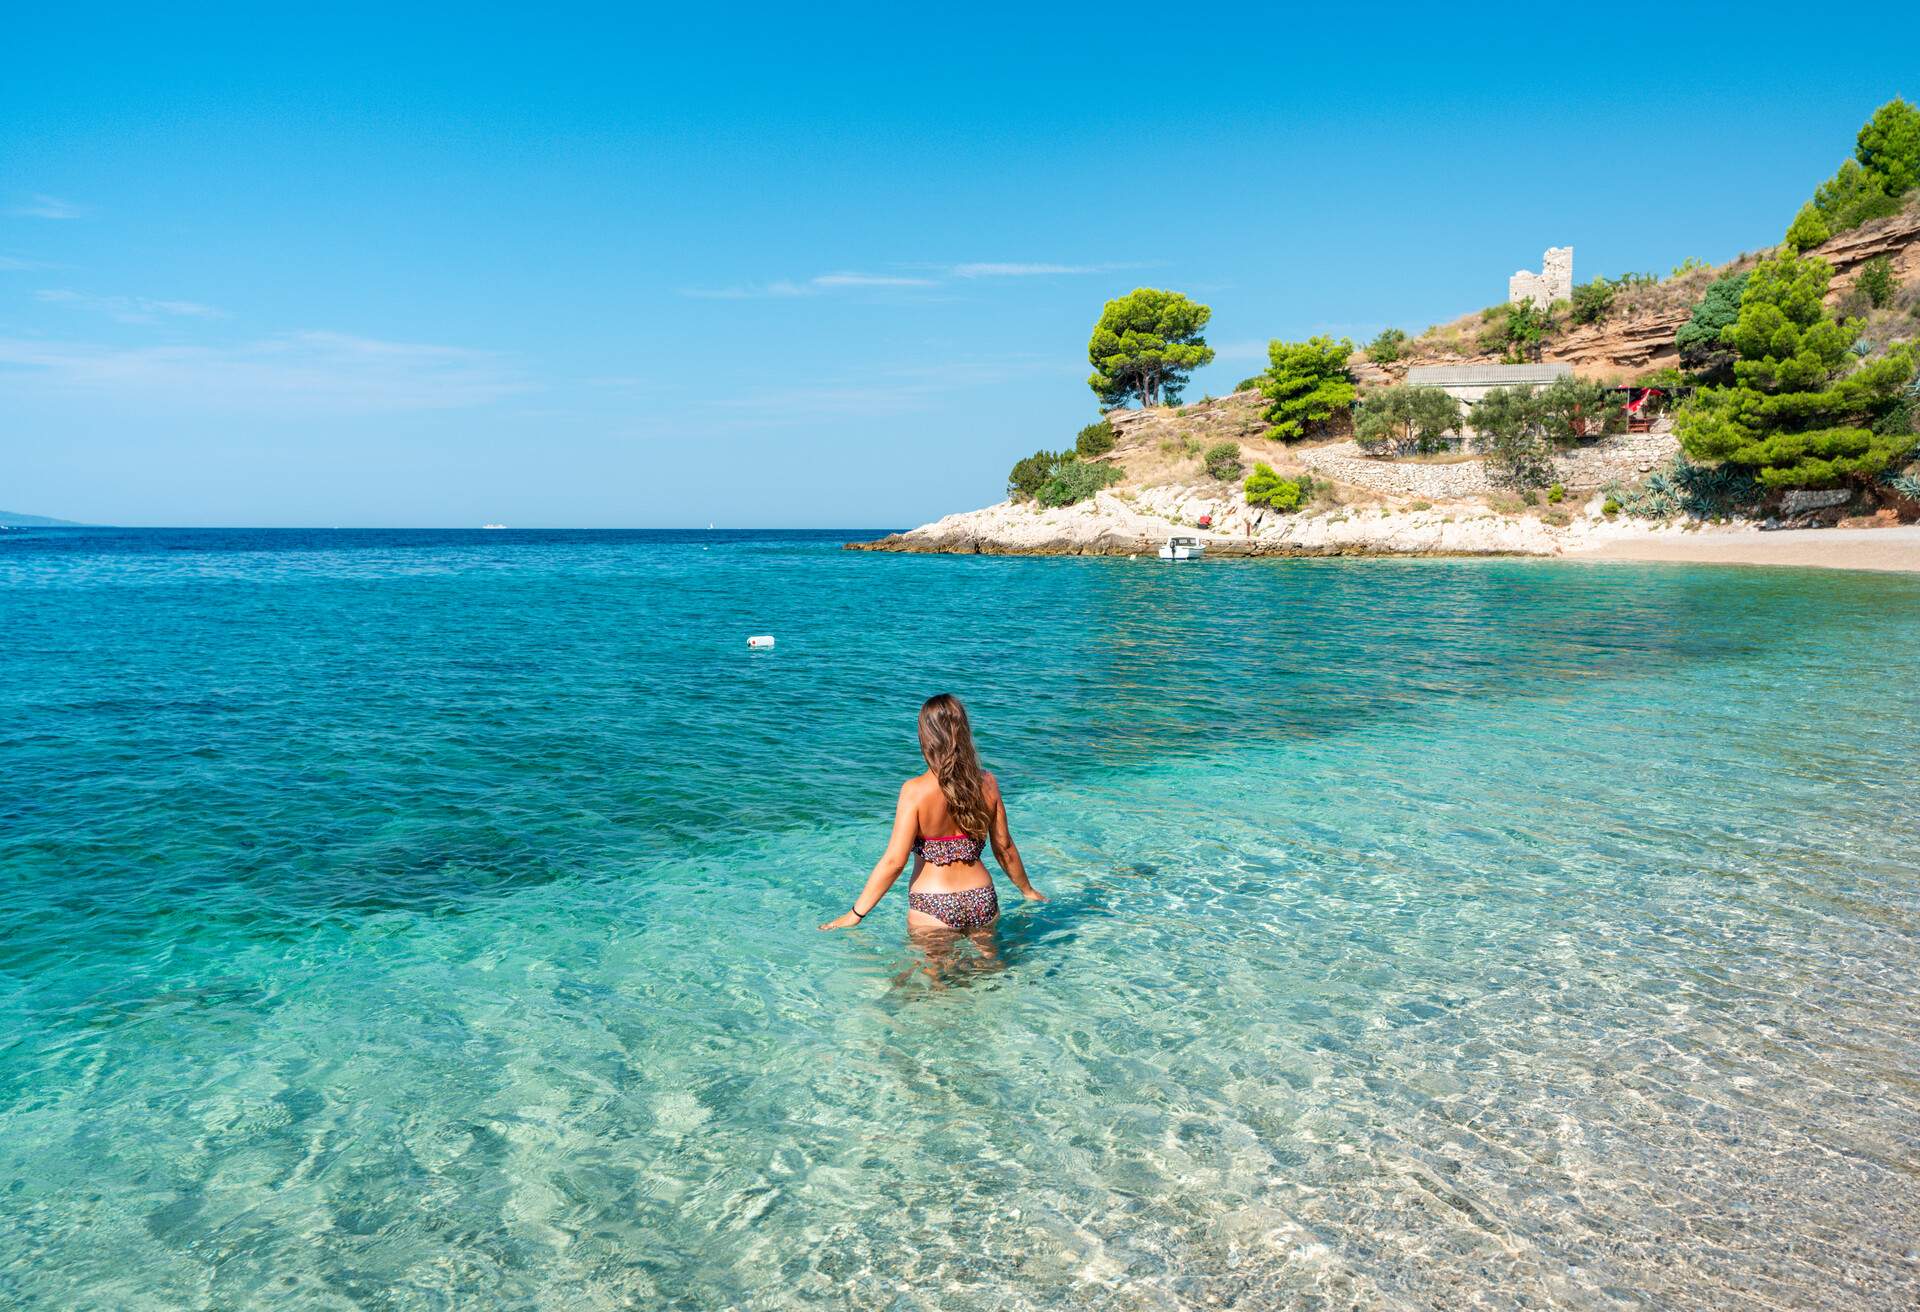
[0,532,1920,1310]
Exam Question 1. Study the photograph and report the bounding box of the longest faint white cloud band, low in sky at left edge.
[0,332,532,413]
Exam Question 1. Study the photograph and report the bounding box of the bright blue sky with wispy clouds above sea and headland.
[0,4,1920,526]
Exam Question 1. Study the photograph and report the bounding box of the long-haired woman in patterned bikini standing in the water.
[820,693,1046,934]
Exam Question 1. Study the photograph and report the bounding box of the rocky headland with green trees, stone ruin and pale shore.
[849,98,1920,569]
